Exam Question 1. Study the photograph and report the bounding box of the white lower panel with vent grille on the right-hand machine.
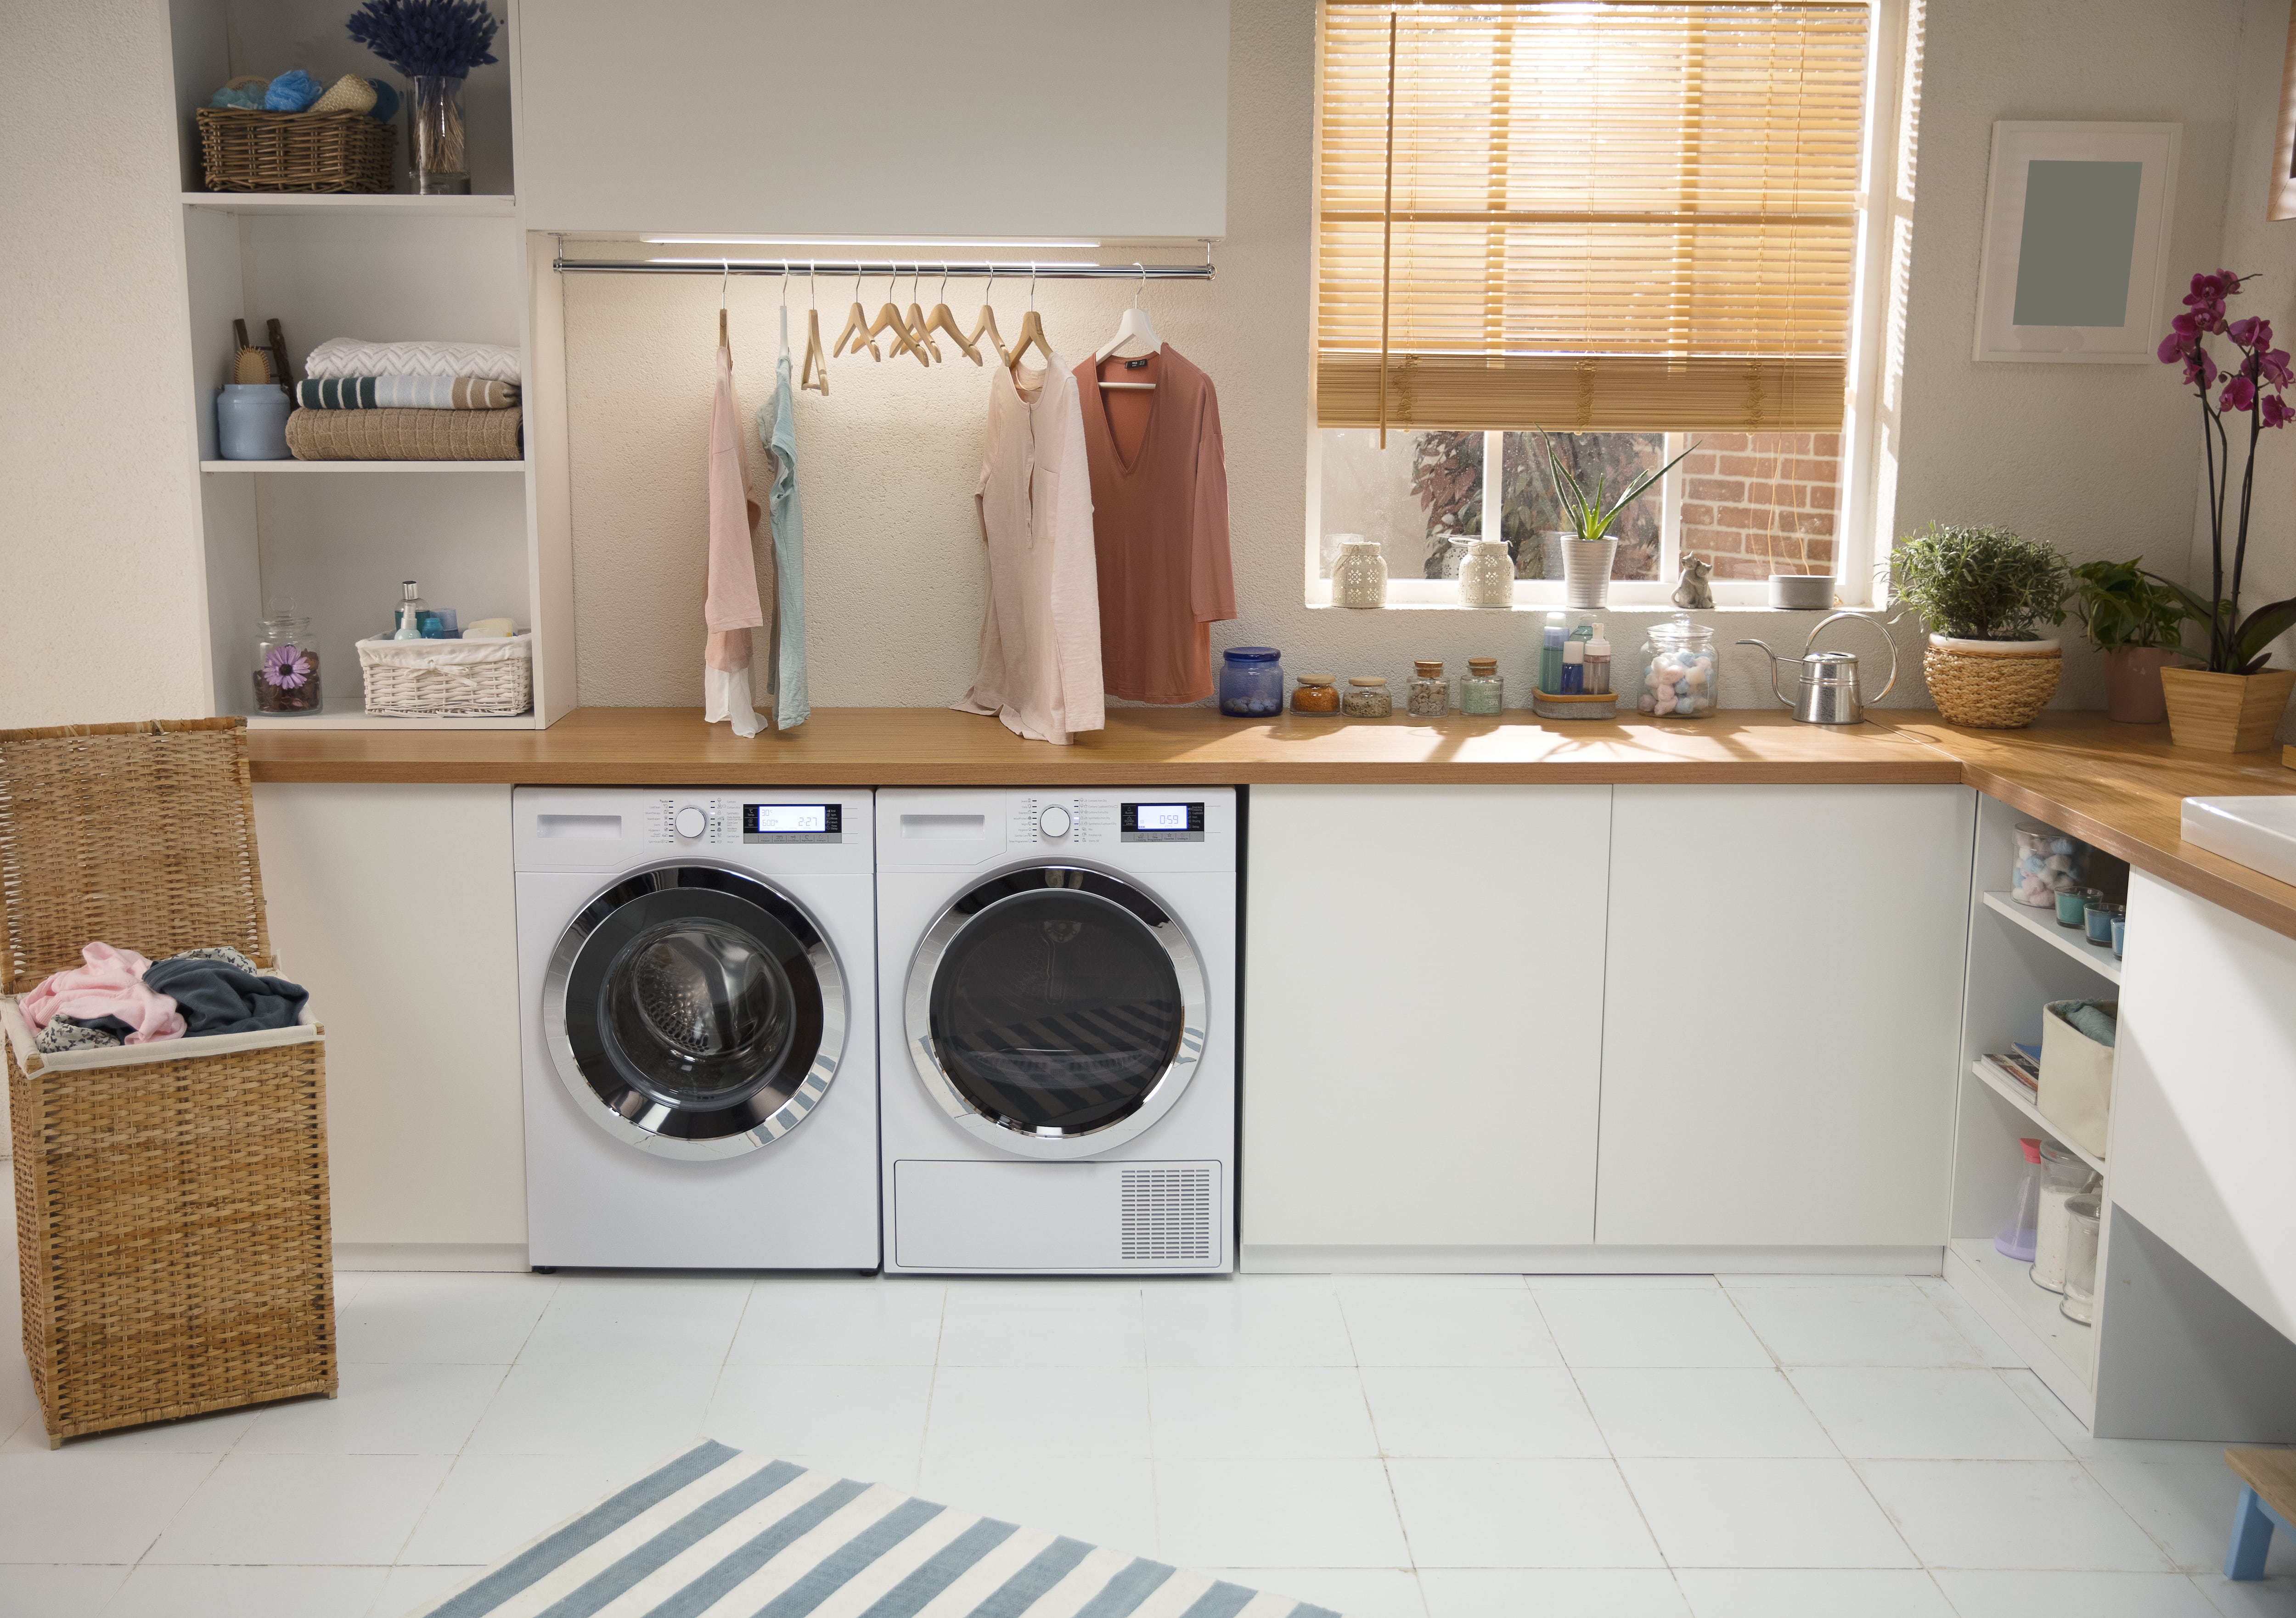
[884,1159,1228,1274]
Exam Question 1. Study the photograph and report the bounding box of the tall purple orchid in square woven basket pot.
[2156,271,2296,753]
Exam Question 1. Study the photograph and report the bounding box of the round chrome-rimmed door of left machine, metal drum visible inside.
[542,865,850,1159]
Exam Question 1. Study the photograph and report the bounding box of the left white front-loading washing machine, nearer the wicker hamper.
[510,787,879,1269]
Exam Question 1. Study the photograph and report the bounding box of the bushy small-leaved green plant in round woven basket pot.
[1892,523,2071,730]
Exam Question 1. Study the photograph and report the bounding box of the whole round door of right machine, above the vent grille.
[905,865,1205,1157]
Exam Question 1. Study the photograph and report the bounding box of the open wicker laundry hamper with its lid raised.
[0,719,335,1448]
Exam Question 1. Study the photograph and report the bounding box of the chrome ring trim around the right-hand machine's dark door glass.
[902,863,1208,1159]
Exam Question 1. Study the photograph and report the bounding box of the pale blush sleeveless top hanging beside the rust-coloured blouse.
[951,358,1104,744]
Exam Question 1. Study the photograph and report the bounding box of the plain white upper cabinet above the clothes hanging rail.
[517,0,1228,239]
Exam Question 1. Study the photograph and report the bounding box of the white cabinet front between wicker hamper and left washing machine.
[255,785,526,1269]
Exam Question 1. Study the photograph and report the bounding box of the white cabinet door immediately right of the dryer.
[1242,787,1609,1262]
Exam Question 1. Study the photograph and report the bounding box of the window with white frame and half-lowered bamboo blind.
[1306,0,1919,606]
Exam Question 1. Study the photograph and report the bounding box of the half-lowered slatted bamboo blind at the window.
[1316,0,1867,432]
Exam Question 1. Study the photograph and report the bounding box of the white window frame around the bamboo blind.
[1302,0,1924,613]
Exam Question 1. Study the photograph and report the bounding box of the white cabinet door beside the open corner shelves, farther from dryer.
[1596,785,1975,1246]
